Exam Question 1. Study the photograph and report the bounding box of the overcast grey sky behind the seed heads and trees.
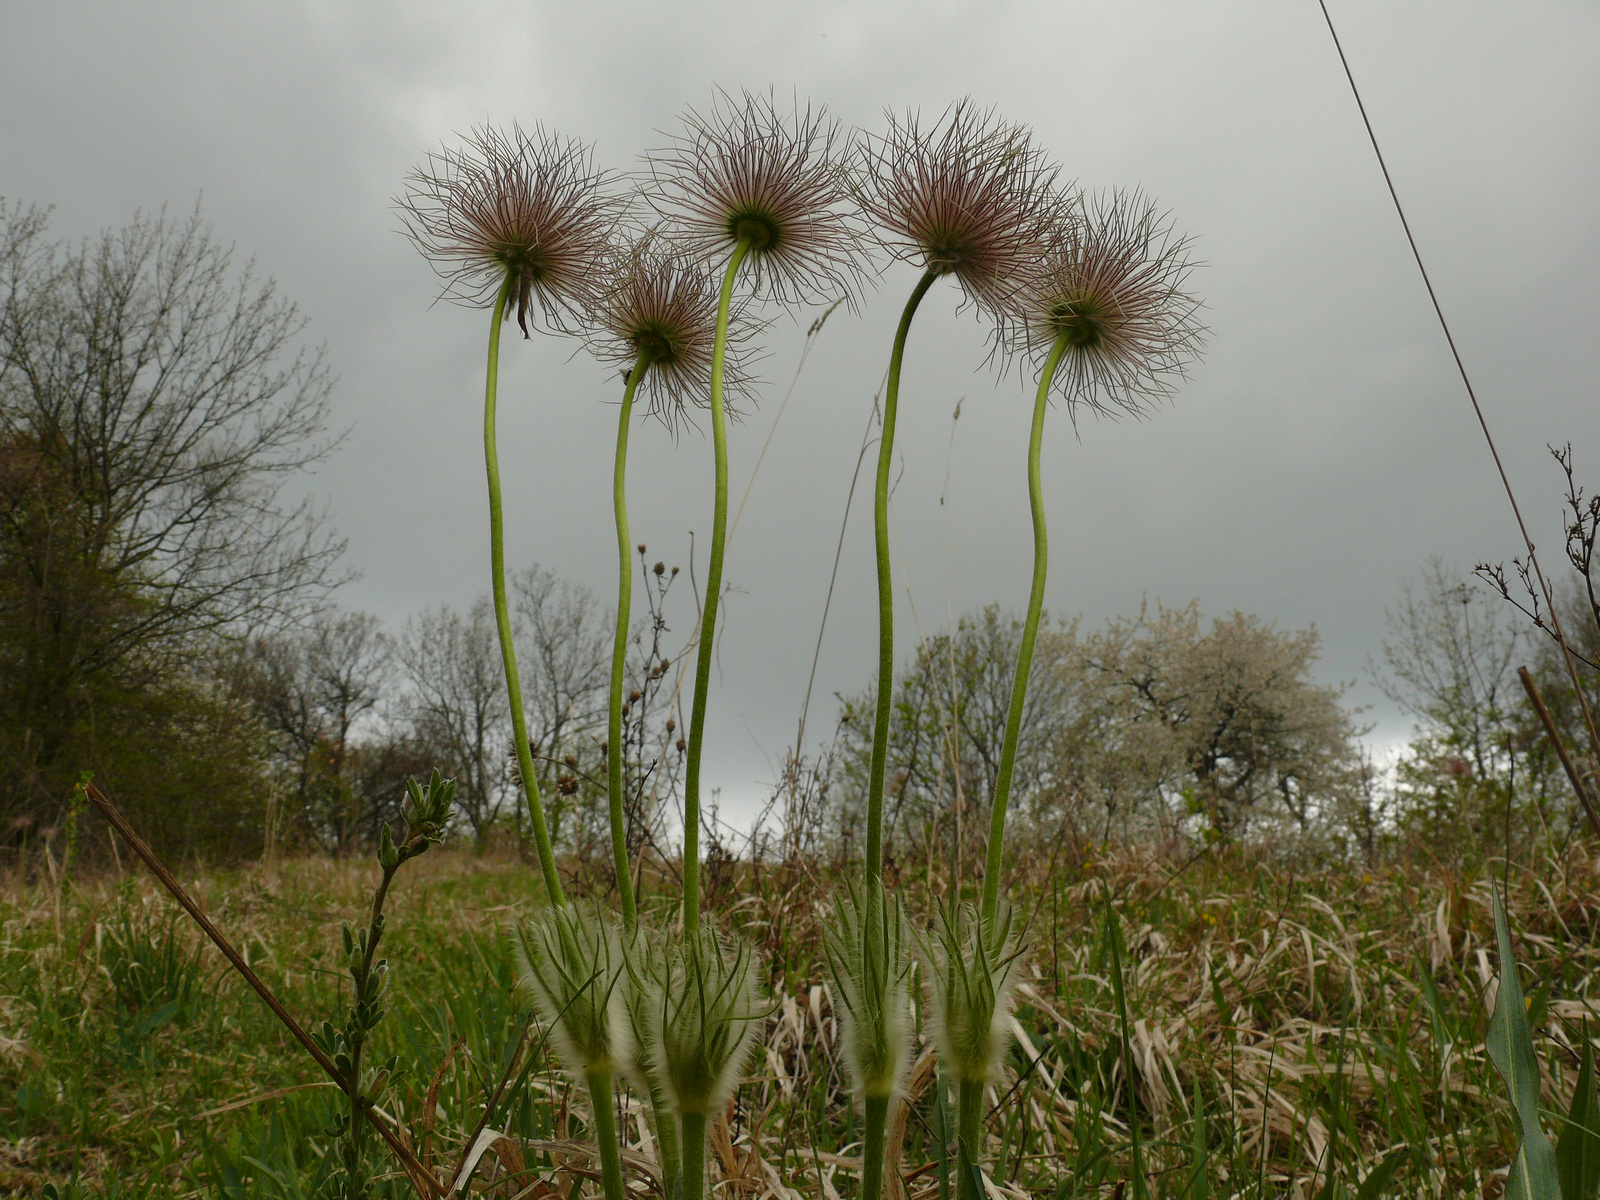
[0,0,1600,825]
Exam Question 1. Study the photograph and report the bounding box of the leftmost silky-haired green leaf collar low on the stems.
[512,904,632,1078]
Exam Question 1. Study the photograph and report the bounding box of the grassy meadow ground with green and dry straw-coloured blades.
[0,845,1600,1200]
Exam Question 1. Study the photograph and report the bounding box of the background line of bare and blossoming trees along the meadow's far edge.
[0,202,1600,869]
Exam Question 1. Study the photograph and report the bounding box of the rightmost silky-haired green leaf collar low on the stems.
[922,906,1024,1083]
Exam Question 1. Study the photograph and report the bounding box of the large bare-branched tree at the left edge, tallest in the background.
[0,205,342,832]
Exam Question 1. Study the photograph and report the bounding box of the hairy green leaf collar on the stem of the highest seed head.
[651,917,766,1114]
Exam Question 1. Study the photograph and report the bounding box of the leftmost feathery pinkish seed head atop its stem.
[395,125,618,334]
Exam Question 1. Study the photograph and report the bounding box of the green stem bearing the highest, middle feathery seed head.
[683,237,750,947]
